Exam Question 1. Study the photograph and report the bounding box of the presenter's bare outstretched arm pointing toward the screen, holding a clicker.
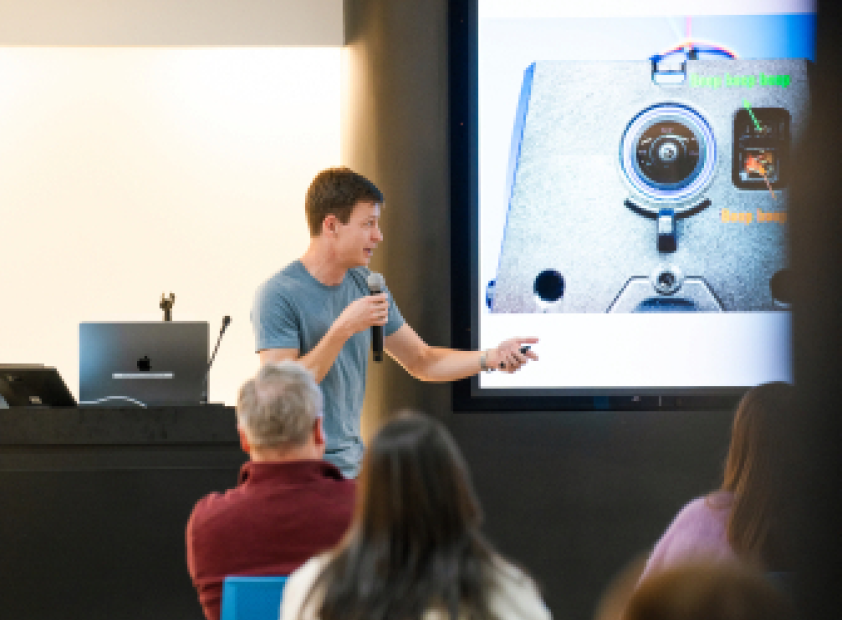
[383,324,538,381]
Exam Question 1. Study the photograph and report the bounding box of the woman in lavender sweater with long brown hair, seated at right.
[641,383,794,580]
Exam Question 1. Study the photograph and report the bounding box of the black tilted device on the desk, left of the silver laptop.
[0,364,76,407]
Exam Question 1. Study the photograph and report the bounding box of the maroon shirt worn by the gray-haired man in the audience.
[187,461,355,620]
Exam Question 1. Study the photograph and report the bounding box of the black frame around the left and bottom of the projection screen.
[440,0,808,412]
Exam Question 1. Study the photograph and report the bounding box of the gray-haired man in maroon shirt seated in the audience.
[186,362,355,620]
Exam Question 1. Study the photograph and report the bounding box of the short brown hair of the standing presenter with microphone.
[304,166,383,237]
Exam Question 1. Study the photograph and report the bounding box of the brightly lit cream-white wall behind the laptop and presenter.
[0,47,341,404]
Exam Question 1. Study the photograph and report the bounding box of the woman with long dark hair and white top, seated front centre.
[281,414,550,620]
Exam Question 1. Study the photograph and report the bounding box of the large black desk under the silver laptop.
[0,405,246,620]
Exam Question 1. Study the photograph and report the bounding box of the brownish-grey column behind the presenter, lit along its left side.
[342,0,450,436]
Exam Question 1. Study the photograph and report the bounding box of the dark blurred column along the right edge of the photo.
[790,0,842,619]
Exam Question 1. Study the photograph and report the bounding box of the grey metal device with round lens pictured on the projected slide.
[490,59,809,312]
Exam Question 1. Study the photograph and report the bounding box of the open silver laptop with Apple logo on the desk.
[79,321,209,407]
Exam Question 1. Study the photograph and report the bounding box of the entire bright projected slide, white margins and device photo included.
[477,0,815,389]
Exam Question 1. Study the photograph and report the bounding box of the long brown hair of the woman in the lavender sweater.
[712,383,797,570]
